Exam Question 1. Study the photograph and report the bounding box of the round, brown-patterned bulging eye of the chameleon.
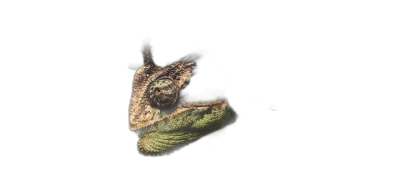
[148,78,180,111]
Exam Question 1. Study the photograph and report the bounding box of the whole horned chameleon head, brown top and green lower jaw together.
[129,41,237,157]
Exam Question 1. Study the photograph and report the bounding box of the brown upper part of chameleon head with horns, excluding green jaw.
[129,42,201,131]
